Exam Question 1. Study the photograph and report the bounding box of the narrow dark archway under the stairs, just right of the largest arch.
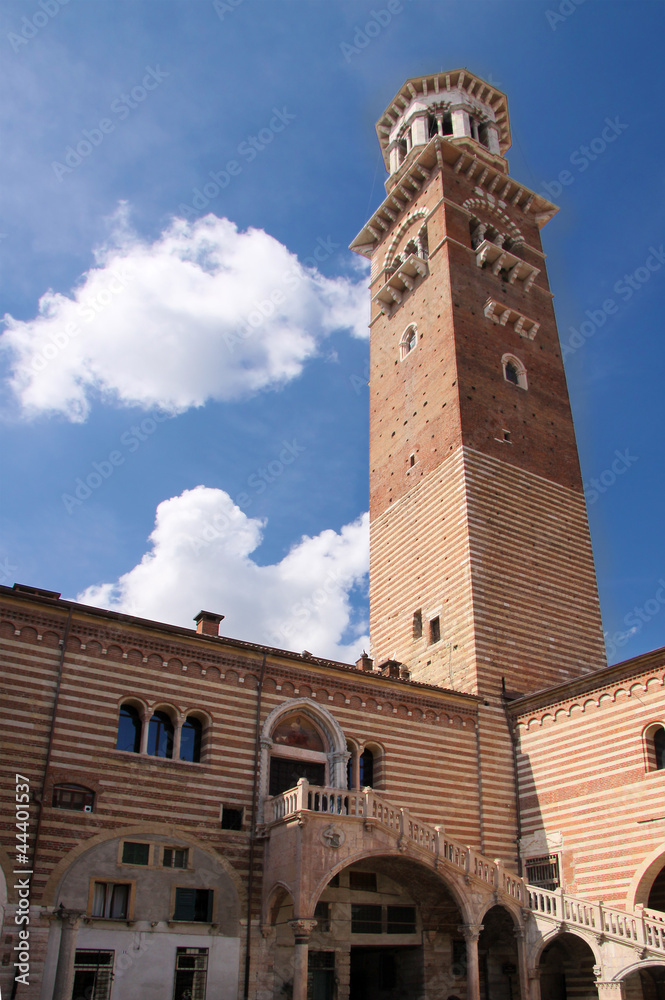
[478,906,521,1000]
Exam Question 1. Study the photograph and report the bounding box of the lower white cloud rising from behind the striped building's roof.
[77,486,369,662]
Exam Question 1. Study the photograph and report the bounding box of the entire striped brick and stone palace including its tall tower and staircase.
[0,70,665,1000]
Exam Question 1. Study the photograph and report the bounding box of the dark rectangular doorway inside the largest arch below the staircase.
[349,947,423,1000]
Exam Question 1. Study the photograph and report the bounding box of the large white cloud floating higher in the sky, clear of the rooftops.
[0,213,367,421]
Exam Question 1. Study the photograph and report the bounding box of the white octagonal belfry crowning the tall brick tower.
[376,69,510,191]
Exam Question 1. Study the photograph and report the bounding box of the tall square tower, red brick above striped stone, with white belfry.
[352,70,605,704]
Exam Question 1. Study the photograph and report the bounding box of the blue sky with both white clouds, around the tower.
[0,0,665,661]
